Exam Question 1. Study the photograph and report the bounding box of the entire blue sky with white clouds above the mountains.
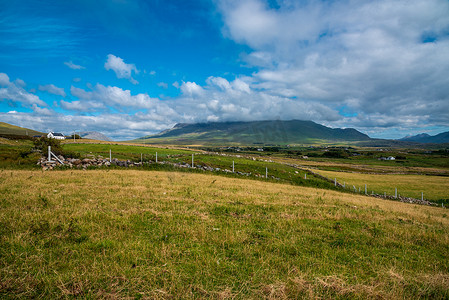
[0,0,449,140]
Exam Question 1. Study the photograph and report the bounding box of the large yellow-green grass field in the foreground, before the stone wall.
[0,170,449,299]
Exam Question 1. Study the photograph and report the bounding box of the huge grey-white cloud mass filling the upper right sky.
[219,0,449,129]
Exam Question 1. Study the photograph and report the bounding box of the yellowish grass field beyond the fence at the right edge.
[314,170,449,202]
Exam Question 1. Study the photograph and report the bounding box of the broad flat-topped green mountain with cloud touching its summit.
[138,120,370,145]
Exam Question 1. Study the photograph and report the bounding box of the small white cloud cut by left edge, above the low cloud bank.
[0,73,47,106]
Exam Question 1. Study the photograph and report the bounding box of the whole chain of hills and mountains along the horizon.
[0,120,449,147]
